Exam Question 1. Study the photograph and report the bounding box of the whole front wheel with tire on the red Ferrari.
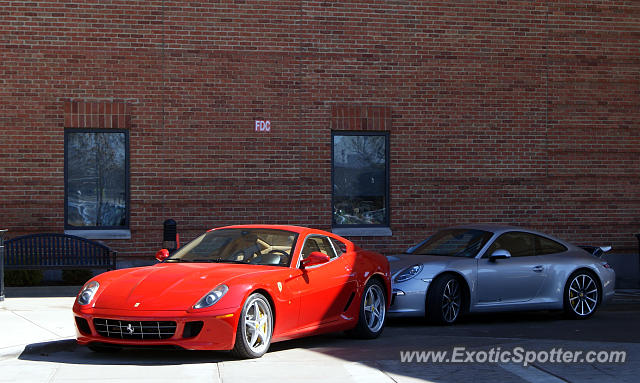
[233,293,273,358]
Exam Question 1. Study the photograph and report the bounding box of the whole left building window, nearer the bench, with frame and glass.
[65,129,129,229]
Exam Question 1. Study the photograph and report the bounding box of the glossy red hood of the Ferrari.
[94,263,269,311]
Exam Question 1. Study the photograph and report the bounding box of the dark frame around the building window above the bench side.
[64,128,131,230]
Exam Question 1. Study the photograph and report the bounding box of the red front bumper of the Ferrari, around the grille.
[74,307,239,350]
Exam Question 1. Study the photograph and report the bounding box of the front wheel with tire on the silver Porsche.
[425,275,467,325]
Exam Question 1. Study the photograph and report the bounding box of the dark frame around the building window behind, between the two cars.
[331,130,391,229]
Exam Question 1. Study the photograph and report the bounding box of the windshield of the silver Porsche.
[411,229,493,258]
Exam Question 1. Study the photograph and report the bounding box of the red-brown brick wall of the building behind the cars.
[0,0,640,257]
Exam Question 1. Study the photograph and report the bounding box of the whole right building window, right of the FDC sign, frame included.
[332,131,389,227]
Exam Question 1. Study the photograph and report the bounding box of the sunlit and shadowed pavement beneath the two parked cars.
[0,286,640,383]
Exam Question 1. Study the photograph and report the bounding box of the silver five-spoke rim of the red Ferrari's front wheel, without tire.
[243,298,273,354]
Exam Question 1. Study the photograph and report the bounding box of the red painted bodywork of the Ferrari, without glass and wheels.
[73,225,391,350]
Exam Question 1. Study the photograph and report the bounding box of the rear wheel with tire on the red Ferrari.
[348,279,387,339]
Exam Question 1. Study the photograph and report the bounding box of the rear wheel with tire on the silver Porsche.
[563,270,602,319]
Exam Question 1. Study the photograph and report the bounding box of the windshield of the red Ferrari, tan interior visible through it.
[165,228,298,266]
